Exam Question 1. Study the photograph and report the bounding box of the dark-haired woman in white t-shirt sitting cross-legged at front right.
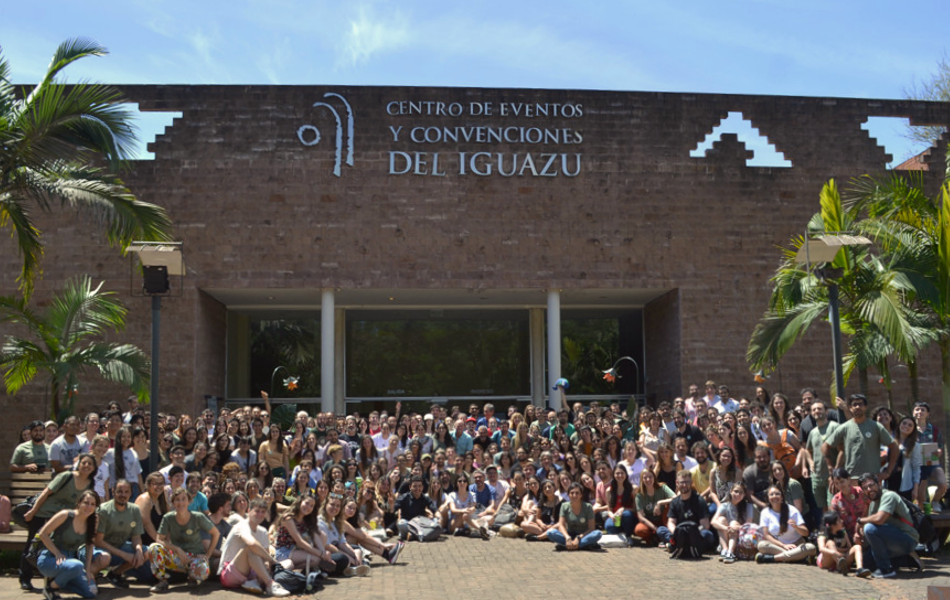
[755,485,818,563]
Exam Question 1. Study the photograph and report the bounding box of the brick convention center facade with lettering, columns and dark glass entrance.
[0,86,950,434]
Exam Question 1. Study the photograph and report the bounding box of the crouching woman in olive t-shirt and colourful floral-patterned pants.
[148,488,221,593]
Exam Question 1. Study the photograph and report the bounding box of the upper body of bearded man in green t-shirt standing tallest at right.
[821,394,899,480]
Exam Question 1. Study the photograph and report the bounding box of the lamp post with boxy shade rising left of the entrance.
[128,242,185,472]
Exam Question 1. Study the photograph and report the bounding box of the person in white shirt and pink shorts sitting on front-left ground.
[218,498,290,598]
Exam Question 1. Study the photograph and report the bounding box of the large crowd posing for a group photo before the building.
[10,381,947,600]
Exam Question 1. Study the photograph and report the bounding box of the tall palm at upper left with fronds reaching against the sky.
[0,39,171,298]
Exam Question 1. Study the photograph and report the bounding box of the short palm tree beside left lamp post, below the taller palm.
[0,276,149,421]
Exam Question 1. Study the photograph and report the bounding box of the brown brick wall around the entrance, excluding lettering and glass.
[0,86,950,462]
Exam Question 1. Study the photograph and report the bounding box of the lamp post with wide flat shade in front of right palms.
[795,232,871,397]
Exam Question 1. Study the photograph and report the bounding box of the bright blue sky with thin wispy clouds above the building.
[0,0,950,160]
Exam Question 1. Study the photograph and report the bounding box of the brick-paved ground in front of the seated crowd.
[0,537,950,600]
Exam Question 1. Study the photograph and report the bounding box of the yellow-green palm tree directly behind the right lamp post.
[746,180,930,404]
